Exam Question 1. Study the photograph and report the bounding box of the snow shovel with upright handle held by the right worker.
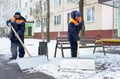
[59,41,96,75]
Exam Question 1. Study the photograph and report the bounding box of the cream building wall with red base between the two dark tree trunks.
[38,0,78,39]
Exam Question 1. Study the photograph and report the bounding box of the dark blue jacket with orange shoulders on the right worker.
[68,17,82,41]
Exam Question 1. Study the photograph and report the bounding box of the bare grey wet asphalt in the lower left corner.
[0,54,54,79]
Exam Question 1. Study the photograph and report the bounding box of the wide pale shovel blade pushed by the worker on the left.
[17,56,49,70]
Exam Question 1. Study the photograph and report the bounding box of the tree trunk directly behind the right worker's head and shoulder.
[79,0,85,38]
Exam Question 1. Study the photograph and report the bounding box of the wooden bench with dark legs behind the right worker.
[54,37,106,57]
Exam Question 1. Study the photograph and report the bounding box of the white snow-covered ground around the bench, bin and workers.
[0,38,120,79]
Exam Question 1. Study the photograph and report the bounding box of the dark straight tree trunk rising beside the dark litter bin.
[46,0,50,42]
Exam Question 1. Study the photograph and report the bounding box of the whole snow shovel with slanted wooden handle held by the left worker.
[8,24,49,70]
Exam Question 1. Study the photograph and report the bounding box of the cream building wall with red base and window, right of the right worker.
[84,0,116,38]
